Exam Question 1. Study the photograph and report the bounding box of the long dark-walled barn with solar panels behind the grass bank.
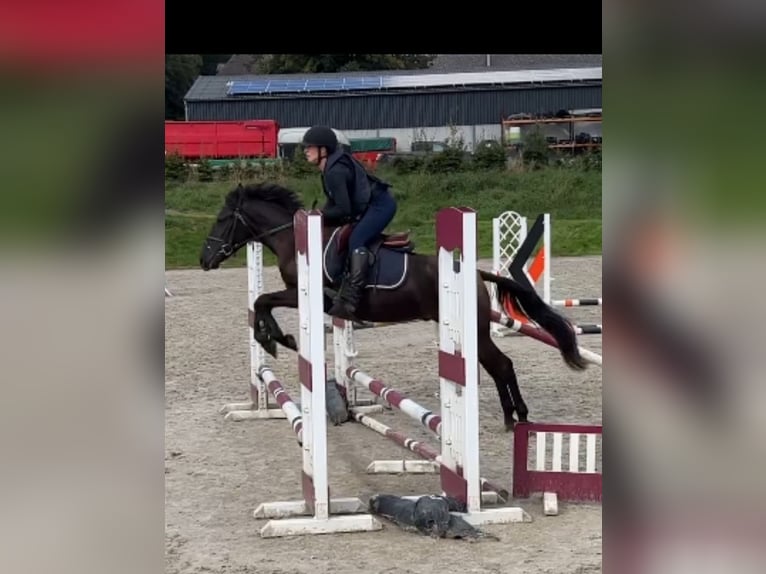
[184,54,602,151]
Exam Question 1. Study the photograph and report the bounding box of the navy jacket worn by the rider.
[322,149,390,225]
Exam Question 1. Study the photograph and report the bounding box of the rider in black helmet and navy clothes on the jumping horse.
[303,126,397,319]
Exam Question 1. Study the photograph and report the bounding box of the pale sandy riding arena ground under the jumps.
[165,257,602,574]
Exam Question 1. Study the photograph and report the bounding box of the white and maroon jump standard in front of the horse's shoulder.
[253,210,383,538]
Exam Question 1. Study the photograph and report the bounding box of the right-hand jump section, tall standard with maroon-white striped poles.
[333,207,531,525]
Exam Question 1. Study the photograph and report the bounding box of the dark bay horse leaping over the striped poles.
[200,183,587,430]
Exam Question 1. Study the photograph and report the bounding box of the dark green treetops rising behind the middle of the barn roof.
[258,54,436,74]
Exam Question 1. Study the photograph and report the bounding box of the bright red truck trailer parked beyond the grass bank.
[165,120,279,159]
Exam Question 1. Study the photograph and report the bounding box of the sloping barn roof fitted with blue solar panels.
[185,66,602,101]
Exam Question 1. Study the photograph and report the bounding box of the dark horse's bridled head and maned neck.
[199,184,303,271]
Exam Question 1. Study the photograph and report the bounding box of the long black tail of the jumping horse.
[479,270,587,371]
